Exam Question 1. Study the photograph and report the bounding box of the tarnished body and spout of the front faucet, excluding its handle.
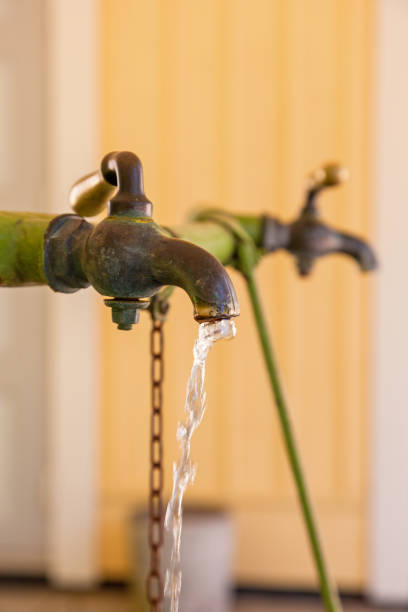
[45,215,239,321]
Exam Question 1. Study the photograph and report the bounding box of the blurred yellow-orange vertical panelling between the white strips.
[101,0,374,588]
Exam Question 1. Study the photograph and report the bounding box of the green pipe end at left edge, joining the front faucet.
[0,212,52,287]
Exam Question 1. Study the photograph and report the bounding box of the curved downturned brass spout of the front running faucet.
[151,236,239,322]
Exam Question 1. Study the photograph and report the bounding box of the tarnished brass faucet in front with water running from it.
[44,151,239,329]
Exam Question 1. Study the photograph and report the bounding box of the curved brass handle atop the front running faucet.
[69,151,152,217]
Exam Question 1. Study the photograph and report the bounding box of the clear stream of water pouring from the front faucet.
[165,319,236,612]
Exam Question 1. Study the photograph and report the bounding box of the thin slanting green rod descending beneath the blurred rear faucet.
[245,273,342,612]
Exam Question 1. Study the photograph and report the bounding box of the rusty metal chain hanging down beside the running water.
[146,316,164,612]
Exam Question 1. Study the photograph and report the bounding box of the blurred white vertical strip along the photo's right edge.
[368,0,408,604]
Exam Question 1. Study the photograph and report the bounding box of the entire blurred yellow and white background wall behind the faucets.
[6,0,408,602]
